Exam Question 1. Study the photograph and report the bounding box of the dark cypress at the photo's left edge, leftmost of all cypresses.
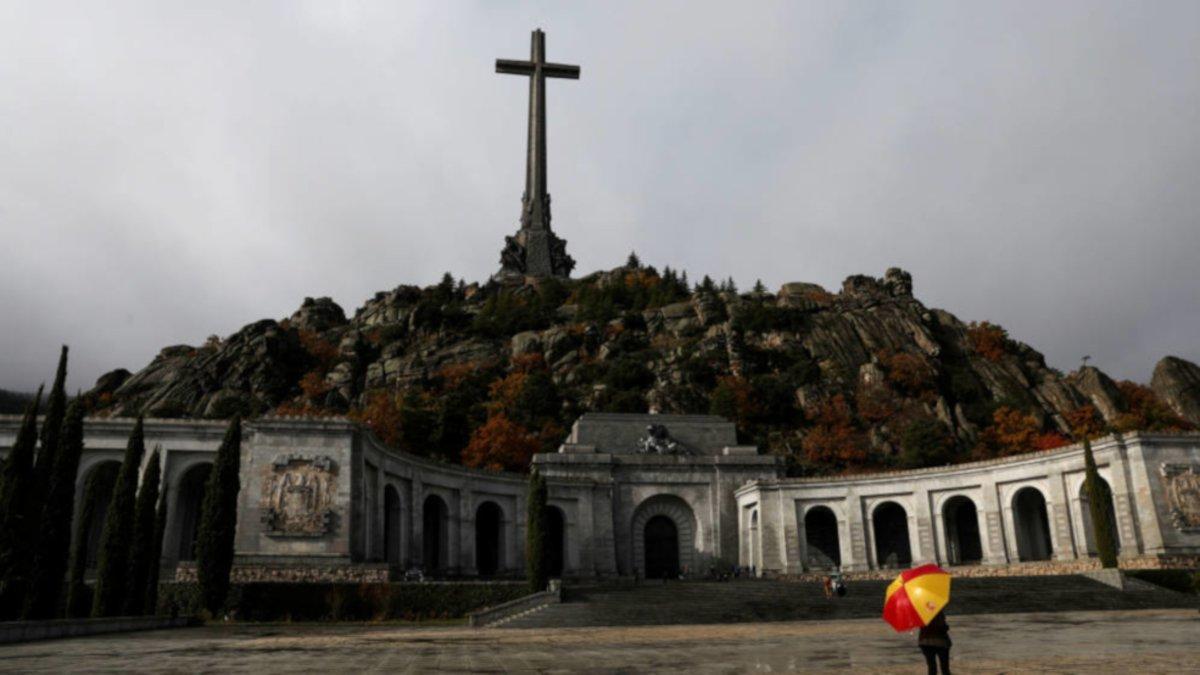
[0,387,42,621]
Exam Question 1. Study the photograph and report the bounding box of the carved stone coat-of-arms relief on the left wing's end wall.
[262,454,337,537]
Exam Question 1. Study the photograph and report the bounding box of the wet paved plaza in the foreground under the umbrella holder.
[0,610,1200,675]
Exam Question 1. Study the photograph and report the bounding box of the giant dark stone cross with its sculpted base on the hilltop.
[496,29,580,279]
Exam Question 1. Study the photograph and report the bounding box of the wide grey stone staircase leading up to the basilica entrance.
[503,575,1200,628]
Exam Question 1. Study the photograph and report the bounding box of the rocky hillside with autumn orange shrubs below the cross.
[88,263,1200,474]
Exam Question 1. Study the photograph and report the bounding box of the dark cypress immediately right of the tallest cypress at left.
[22,396,83,619]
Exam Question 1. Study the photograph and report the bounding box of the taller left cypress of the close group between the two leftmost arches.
[91,417,145,616]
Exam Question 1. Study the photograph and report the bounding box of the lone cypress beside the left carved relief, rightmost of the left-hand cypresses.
[196,417,241,615]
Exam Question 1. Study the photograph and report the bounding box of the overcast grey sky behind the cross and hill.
[0,0,1200,390]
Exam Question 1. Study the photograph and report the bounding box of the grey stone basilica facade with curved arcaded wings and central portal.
[0,413,1200,580]
